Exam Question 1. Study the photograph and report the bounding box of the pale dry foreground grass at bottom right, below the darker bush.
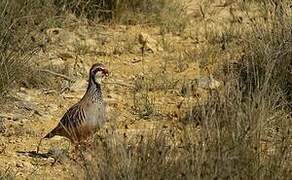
[80,77,292,179]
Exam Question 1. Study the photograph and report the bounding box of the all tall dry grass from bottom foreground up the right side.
[77,0,292,179]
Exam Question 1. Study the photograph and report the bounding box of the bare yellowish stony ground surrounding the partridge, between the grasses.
[0,1,264,179]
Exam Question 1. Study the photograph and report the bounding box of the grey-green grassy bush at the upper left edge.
[0,0,52,95]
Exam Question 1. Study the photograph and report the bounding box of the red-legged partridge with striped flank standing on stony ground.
[37,63,109,152]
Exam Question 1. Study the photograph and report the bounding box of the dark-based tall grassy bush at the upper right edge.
[236,1,292,108]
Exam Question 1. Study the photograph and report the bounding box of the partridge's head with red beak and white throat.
[89,63,109,83]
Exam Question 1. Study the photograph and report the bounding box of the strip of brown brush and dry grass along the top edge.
[54,0,188,33]
